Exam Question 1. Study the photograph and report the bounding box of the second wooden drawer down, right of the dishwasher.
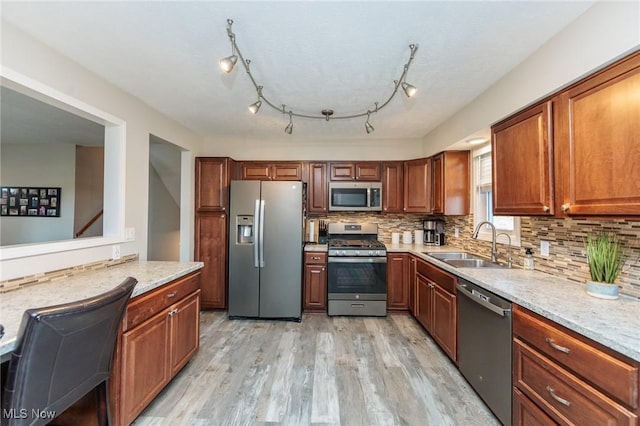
[513,339,638,426]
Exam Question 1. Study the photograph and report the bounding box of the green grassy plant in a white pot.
[585,232,624,299]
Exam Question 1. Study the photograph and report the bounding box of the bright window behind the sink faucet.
[473,146,520,246]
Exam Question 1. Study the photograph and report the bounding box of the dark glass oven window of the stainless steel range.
[328,262,387,294]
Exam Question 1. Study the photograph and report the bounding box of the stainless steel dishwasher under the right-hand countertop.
[457,279,512,425]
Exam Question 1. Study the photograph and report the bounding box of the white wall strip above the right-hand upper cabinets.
[423,1,640,155]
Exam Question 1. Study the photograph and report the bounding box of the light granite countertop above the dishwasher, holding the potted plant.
[387,244,640,361]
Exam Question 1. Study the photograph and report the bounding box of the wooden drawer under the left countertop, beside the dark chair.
[123,272,200,331]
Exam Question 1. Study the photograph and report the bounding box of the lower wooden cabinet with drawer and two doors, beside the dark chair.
[111,272,200,425]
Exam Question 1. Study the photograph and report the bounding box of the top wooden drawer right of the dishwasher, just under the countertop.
[513,308,639,409]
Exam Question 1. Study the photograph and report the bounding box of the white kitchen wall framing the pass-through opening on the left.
[0,21,202,280]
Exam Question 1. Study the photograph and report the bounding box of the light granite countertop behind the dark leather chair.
[0,262,203,357]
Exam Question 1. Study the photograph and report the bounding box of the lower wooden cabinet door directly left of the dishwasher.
[431,284,458,362]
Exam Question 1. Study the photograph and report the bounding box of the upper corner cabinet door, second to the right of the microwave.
[404,158,431,213]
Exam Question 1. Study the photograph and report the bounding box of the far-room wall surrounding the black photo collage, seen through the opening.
[0,141,76,246]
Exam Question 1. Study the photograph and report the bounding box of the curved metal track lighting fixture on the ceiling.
[218,19,418,135]
